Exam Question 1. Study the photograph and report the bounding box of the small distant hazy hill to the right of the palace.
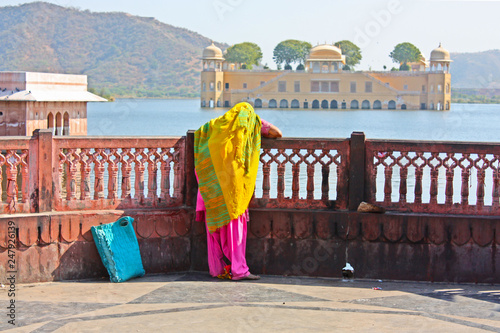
[450,50,500,89]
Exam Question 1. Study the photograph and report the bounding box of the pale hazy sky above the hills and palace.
[0,0,500,70]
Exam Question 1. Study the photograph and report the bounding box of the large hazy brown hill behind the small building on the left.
[0,2,225,97]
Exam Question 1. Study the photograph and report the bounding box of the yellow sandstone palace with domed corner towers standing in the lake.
[201,43,451,110]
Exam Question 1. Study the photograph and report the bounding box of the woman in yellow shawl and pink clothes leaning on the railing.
[194,103,281,280]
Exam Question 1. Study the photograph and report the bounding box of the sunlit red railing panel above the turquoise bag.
[53,137,185,210]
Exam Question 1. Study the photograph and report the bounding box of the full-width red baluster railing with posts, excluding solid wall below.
[0,130,500,215]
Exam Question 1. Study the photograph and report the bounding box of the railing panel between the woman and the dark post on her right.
[251,138,349,209]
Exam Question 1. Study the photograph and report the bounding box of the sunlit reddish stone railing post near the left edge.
[33,129,53,212]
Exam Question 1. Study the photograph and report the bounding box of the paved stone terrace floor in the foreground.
[0,272,500,333]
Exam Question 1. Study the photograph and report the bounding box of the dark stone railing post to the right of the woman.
[349,132,365,210]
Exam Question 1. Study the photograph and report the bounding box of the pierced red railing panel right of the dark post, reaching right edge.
[365,140,500,215]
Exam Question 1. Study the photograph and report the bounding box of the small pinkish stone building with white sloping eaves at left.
[0,72,106,136]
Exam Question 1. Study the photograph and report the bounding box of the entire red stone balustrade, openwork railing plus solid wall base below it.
[0,130,500,283]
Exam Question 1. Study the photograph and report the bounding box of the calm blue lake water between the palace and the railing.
[87,99,500,142]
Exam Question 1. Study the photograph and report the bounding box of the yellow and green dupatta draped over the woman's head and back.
[194,103,262,233]
